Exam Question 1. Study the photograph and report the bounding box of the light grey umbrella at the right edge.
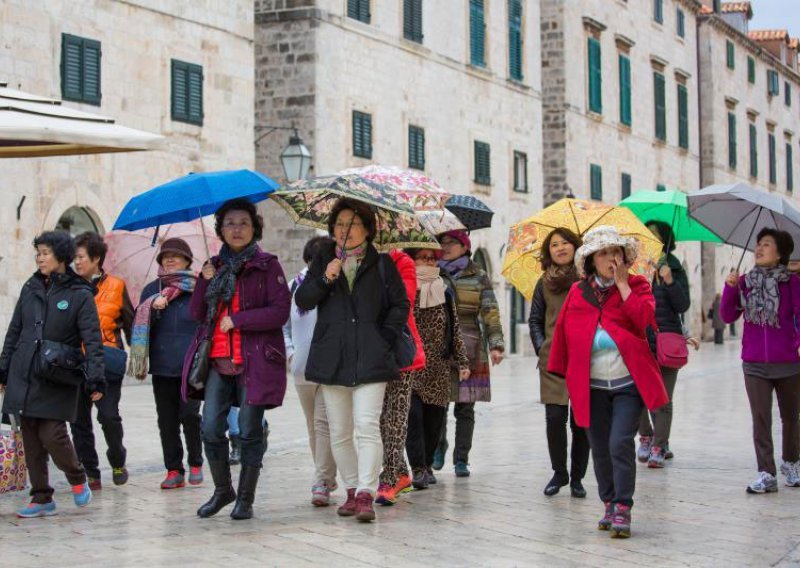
[687,183,800,266]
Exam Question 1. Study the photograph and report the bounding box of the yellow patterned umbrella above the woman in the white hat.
[502,198,663,300]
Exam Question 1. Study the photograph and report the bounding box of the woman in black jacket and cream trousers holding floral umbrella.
[295,199,409,521]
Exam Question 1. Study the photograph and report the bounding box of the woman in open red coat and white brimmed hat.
[547,226,669,537]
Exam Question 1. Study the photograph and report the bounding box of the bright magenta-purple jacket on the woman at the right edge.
[720,274,800,363]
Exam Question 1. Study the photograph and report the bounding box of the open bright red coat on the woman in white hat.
[547,276,669,428]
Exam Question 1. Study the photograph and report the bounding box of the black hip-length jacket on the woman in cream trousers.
[295,244,410,387]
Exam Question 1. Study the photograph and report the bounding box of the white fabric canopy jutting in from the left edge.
[0,83,164,158]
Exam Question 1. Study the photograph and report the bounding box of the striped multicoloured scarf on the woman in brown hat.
[128,268,197,380]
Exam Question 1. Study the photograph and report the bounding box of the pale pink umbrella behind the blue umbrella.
[103,219,222,305]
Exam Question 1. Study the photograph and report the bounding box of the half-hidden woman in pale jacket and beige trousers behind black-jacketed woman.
[283,237,336,507]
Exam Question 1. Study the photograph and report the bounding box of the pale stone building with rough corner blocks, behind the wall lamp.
[255,0,542,356]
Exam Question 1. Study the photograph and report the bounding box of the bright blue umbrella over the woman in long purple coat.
[114,170,278,231]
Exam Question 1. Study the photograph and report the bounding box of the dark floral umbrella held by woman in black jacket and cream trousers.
[270,174,440,250]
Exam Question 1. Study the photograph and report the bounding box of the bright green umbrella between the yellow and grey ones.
[619,190,722,243]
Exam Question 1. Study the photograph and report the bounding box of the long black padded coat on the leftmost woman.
[0,269,106,422]
